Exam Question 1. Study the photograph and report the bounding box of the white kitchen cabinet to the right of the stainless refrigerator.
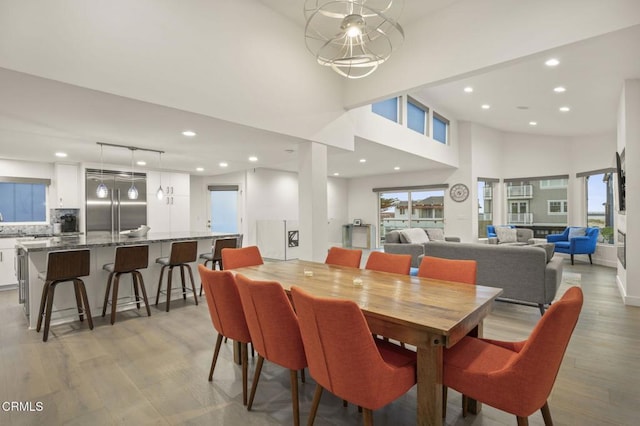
[147,172,190,232]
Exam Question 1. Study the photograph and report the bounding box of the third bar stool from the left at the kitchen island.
[156,241,198,312]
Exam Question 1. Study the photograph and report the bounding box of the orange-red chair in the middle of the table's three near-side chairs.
[236,274,307,426]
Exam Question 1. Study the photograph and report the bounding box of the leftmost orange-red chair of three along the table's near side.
[198,265,251,405]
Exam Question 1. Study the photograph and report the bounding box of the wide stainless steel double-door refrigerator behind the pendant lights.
[85,169,147,237]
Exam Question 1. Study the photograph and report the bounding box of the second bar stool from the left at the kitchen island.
[102,246,151,325]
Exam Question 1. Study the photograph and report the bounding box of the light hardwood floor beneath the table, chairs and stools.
[0,260,640,426]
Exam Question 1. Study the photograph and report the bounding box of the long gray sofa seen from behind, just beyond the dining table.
[424,241,563,313]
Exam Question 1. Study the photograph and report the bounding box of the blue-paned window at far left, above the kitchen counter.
[0,178,48,223]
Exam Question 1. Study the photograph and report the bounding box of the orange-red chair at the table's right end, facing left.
[443,287,583,426]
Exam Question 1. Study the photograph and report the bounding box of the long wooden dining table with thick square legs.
[234,260,502,425]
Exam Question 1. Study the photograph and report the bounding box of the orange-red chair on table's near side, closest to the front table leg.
[291,286,416,425]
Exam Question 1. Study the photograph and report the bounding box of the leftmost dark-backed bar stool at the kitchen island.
[36,250,93,342]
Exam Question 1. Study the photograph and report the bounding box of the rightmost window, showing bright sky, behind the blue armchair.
[584,171,615,244]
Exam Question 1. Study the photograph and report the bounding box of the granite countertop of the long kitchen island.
[16,232,239,252]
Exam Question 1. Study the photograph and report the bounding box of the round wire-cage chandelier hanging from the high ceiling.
[304,0,404,78]
